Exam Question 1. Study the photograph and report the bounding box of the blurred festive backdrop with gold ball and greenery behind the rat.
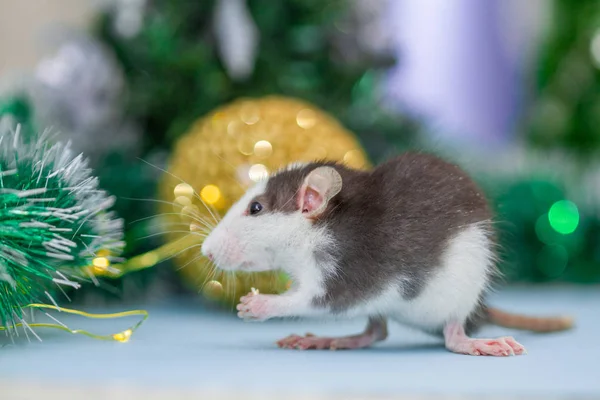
[0,0,600,396]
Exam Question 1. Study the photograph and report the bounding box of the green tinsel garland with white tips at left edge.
[0,120,124,334]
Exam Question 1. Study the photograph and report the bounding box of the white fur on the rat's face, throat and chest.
[202,177,333,316]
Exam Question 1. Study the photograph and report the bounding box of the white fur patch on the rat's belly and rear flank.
[348,224,494,329]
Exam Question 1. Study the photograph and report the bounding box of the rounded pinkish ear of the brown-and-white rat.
[298,167,342,218]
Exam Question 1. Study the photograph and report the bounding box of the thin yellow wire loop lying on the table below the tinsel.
[0,303,148,343]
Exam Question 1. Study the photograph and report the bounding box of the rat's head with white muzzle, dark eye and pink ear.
[202,164,342,271]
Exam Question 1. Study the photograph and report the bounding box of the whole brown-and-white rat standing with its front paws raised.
[201,152,572,356]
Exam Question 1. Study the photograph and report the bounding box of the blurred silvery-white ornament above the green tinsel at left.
[30,36,140,165]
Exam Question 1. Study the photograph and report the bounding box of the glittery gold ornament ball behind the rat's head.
[160,96,370,305]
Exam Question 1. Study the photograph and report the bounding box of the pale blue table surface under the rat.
[0,286,600,399]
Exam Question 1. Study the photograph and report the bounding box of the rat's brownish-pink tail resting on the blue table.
[487,307,573,332]
